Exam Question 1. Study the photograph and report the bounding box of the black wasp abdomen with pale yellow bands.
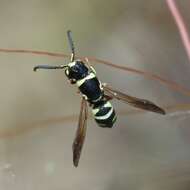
[92,101,117,128]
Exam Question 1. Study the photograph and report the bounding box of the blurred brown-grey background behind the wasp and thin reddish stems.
[0,0,190,190]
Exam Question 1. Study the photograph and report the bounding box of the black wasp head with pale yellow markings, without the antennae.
[65,60,88,81]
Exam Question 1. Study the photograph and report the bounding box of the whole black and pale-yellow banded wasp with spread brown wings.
[33,30,165,167]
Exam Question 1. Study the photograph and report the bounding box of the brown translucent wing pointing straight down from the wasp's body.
[73,98,88,167]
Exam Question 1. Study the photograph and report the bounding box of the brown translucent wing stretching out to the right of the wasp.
[103,85,166,115]
